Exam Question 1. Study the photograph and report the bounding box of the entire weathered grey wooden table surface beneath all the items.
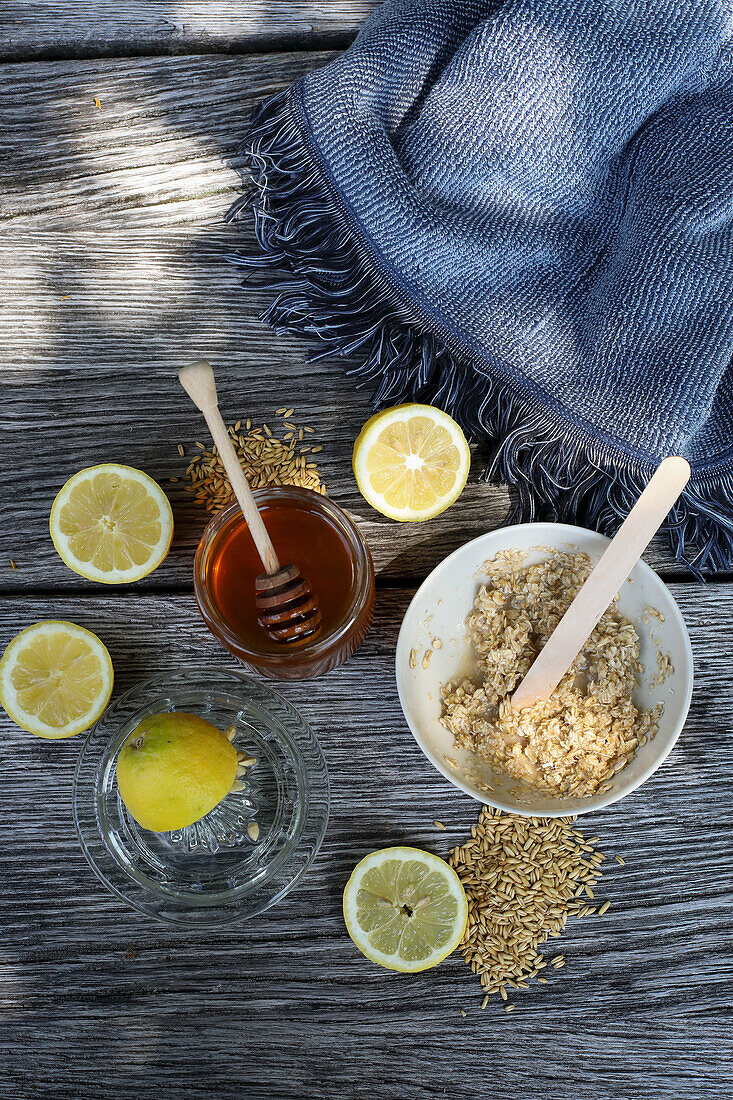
[0,0,733,1100]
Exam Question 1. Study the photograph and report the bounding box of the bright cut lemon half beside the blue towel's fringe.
[353,405,471,520]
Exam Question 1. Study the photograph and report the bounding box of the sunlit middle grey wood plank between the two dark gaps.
[0,54,708,591]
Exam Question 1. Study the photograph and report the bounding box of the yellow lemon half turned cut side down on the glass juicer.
[117,712,237,833]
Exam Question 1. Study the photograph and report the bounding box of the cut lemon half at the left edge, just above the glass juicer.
[0,619,114,737]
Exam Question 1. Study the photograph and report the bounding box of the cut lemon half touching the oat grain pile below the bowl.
[343,848,468,972]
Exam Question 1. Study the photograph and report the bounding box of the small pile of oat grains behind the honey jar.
[178,407,326,512]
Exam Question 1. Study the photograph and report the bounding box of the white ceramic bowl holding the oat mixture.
[396,524,692,817]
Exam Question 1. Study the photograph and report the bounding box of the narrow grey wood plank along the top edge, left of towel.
[0,0,379,62]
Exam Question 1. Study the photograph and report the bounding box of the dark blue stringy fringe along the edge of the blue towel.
[227,89,733,578]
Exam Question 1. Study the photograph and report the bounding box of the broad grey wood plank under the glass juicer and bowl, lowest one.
[0,584,733,1100]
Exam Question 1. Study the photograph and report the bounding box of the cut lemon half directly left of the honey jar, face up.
[50,462,173,584]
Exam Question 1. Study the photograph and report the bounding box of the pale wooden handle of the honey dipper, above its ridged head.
[178,360,280,575]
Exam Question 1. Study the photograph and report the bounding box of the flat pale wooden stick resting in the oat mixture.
[512,458,690,711]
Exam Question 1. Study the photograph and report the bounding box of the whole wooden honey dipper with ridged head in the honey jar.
[178,360,322,645]
